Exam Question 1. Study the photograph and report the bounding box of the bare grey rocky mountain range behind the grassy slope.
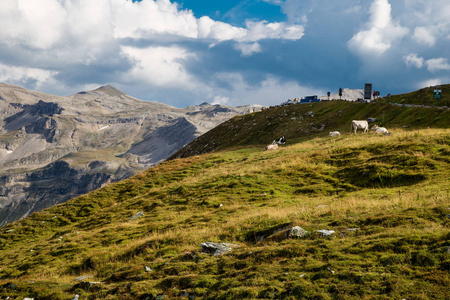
[0,84,259,226]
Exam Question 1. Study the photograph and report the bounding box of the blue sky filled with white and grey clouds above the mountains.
[0,0,450,108]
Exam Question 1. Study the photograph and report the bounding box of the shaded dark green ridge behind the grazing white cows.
[171,101,450,158]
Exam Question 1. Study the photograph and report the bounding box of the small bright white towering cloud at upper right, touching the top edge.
[348,0,408,56]
